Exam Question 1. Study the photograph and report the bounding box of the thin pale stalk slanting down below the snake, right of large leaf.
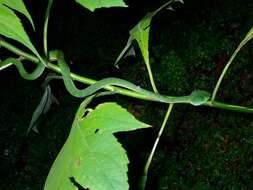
[140,104,174,190]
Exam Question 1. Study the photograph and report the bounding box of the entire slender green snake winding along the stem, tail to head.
[0,50,210,106]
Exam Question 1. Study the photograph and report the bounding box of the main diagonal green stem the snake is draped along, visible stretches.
[0,38,253,113]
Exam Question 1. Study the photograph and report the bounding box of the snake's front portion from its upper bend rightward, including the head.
[49,50,210,106]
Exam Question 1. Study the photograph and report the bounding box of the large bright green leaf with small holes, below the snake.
[44,97,149,190]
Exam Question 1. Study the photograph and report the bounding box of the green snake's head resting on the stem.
[190,90,211,106]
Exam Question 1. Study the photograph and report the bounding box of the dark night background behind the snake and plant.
[0,0,253,190]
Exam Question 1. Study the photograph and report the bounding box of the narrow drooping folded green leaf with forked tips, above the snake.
[115,0,183,67]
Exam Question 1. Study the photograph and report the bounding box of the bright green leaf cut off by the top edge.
[76,0,127,11]
